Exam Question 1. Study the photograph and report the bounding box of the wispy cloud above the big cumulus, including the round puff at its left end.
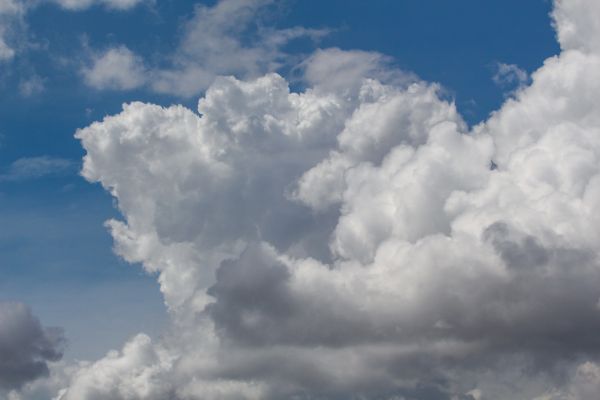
[84,0,326,97]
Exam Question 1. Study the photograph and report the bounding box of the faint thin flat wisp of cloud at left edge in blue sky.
[0,156,77,182]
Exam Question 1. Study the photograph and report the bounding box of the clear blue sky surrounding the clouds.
[0,0,559,358]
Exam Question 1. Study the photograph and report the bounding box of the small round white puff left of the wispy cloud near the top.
[81,46,147,90]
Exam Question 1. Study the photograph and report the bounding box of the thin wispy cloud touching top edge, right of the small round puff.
[152,0,323,96]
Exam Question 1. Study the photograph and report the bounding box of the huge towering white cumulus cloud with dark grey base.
[52,0,600,400]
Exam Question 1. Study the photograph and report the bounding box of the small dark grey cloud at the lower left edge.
[0,303,64,390]
